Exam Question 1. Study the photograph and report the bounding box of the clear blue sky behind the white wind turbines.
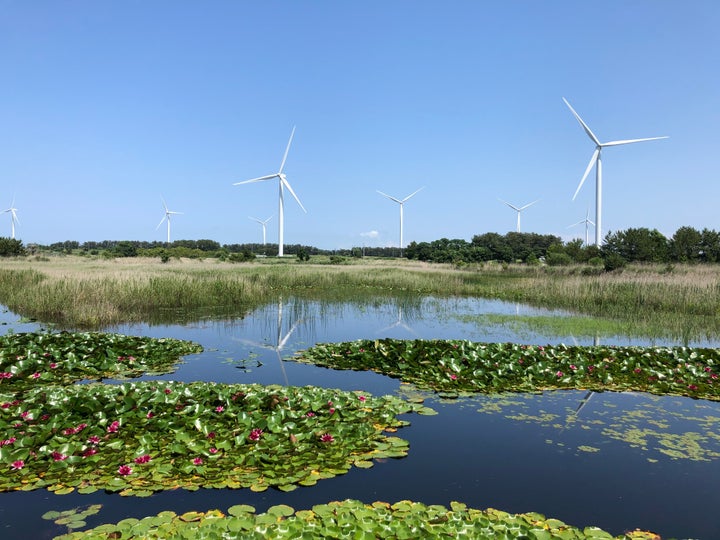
[0,0,720,249]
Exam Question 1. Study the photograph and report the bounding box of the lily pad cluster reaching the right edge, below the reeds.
[294,339,720,400]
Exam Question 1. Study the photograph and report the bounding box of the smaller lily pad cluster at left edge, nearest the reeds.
[0,332,203,391]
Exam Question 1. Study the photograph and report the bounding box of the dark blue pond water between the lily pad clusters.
[0,298,720,538]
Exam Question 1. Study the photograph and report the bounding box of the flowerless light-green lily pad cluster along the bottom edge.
[58,500,660,540]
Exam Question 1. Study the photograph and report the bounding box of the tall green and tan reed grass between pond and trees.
[0,256,720,338]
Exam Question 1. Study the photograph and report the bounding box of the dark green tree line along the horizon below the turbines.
[0,227,720,270]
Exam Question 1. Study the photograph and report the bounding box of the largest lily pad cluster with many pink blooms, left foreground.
[0,381,430,496]
